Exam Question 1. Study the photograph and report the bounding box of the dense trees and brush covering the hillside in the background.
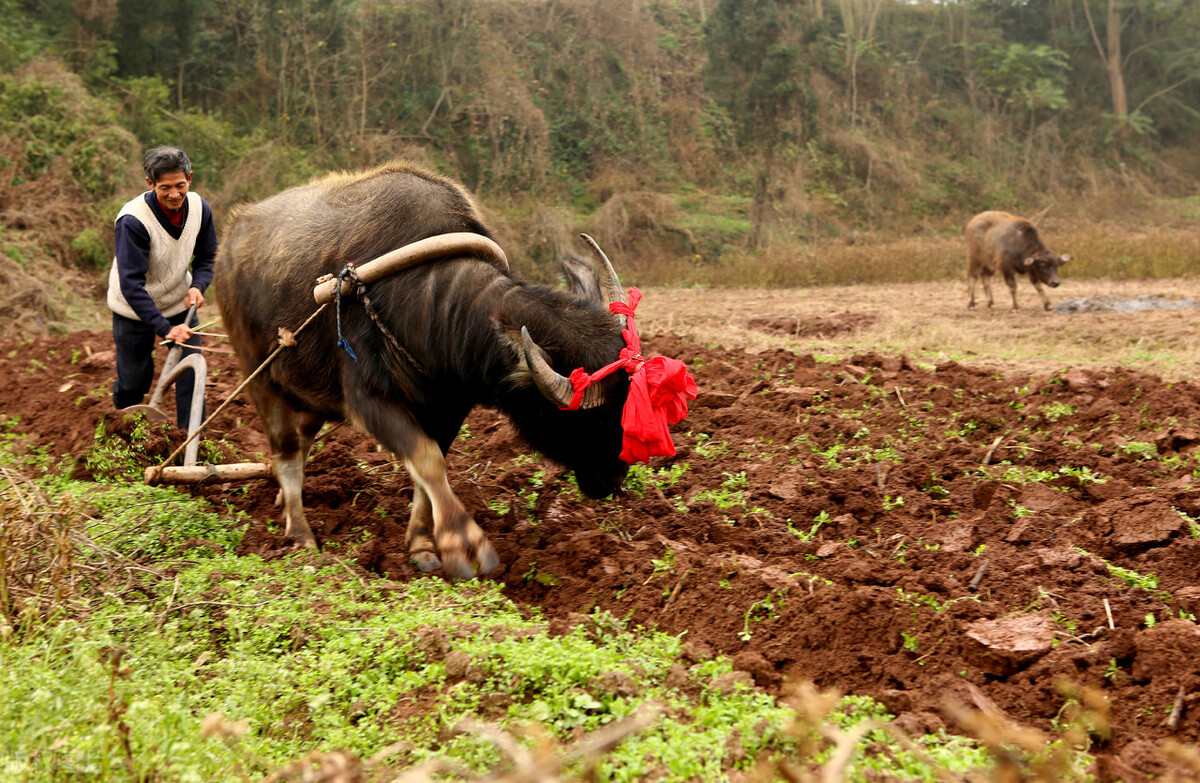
[0,0,1200,272]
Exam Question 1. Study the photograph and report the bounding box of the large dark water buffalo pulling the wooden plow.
[215,162,630,578]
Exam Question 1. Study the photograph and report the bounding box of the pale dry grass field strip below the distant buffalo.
[641,278,1200,379]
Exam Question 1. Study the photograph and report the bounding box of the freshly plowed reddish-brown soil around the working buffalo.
[0,297,1200,781]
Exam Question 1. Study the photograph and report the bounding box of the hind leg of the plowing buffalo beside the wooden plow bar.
[250,384,323,549]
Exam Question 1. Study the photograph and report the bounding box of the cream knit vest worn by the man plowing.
[108,192,204,319]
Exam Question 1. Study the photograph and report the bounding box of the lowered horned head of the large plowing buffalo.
[502,238,629,497]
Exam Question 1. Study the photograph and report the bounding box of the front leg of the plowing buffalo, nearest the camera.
[346,393,500,579]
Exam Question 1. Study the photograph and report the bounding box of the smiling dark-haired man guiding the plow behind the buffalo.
[108,147,217,430]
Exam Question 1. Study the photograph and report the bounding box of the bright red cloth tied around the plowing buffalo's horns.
[564,288,697,464]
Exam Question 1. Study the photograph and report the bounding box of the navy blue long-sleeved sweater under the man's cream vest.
[113,190,217,337]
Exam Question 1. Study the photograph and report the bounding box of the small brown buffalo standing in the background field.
[966,211,1070,310]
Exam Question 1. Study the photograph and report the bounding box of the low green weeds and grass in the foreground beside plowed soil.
[0,434,1099,782]
